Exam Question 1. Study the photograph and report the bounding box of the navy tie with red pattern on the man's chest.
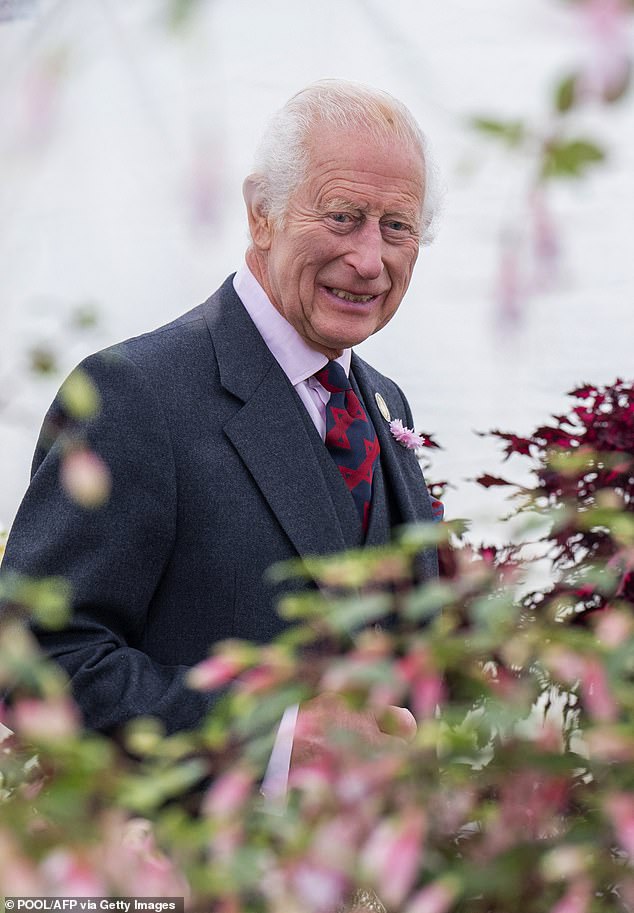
[315,361,380,533]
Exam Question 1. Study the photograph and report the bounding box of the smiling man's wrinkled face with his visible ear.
[249,126,424,358]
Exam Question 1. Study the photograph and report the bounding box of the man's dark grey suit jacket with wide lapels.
[2,277,436,731]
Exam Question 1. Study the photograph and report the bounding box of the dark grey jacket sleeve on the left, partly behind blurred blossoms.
[2,351,213,732]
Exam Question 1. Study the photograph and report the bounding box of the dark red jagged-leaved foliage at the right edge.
[486,379,634,613]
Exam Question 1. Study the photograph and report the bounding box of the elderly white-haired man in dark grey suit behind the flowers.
[3,80,436,736]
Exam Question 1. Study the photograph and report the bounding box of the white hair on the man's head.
[252,79,439,244]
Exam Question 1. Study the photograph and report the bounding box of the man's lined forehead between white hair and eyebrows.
[304,124,425,212]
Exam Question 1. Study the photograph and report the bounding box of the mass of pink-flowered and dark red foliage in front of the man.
[0,381,634,913]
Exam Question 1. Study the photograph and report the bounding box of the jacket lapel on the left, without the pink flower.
[203,278,345,555]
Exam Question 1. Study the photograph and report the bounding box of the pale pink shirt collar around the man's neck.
[233,263,351,386]
